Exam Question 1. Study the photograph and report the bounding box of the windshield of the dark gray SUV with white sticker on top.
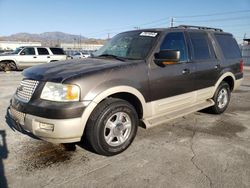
[93,31,158,60]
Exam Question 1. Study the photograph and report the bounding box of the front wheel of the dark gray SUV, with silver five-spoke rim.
[86,98,139,156]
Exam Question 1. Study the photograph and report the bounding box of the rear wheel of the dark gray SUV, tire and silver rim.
[208,81,231,114]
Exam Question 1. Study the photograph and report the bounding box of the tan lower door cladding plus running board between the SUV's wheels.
[143,87,214,128]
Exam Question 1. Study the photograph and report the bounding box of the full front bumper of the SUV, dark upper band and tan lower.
[8,97,88,143]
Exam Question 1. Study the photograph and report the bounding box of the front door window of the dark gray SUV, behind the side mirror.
[161,33,187,61]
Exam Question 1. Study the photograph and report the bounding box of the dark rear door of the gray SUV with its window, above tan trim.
[188,31,221,90]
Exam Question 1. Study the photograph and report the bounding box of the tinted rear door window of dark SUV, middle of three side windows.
[190,33,211,59]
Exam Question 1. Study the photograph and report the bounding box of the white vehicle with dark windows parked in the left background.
[0,46,67,71]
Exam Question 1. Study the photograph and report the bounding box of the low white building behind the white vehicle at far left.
[0,41,42,50]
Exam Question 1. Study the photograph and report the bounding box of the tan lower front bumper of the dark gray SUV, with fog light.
[8,108,83,143]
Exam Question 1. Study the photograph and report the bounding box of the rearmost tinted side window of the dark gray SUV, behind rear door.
[215,34,241,59]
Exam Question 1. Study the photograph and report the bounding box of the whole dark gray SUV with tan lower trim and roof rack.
[9,26,243,155]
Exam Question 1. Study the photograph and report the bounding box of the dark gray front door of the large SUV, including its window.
[149,32,195,103]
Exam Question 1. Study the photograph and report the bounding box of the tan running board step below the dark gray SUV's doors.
[142,99,214,129]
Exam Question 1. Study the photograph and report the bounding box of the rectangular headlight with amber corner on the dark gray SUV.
[41,82,80,102]
